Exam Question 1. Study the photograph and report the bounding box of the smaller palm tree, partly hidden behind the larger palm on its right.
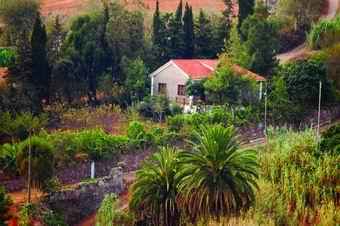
[129,147,180,226]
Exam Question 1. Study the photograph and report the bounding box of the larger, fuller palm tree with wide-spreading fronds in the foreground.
[176,125,259,222]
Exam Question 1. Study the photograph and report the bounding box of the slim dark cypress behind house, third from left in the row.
[183,3,195,58]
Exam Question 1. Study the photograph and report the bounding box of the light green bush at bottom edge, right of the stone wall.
[96,194,134,226]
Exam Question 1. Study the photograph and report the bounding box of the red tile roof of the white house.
[171,59,266,81]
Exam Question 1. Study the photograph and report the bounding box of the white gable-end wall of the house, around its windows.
[151,62,188,101]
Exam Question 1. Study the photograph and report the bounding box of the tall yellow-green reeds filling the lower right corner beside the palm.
[254,129,339,225]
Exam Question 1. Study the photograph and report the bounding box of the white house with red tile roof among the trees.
[150,59,266,105]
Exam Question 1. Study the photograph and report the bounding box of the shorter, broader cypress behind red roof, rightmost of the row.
[195,10,215,58]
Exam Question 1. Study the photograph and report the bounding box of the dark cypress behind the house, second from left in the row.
[169,0,183,58]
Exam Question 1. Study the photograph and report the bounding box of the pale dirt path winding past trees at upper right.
[277,0,340,63]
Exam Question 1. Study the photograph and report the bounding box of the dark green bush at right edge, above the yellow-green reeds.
[320,124,340,155]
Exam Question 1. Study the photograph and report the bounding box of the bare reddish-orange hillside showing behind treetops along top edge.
[42,0,236,15]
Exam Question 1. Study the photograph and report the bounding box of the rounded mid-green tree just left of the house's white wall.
[125,58,151,103]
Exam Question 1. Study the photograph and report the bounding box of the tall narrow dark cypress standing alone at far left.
[31,14,51,102]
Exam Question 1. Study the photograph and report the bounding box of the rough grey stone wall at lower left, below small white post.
[44,167,125,225]
